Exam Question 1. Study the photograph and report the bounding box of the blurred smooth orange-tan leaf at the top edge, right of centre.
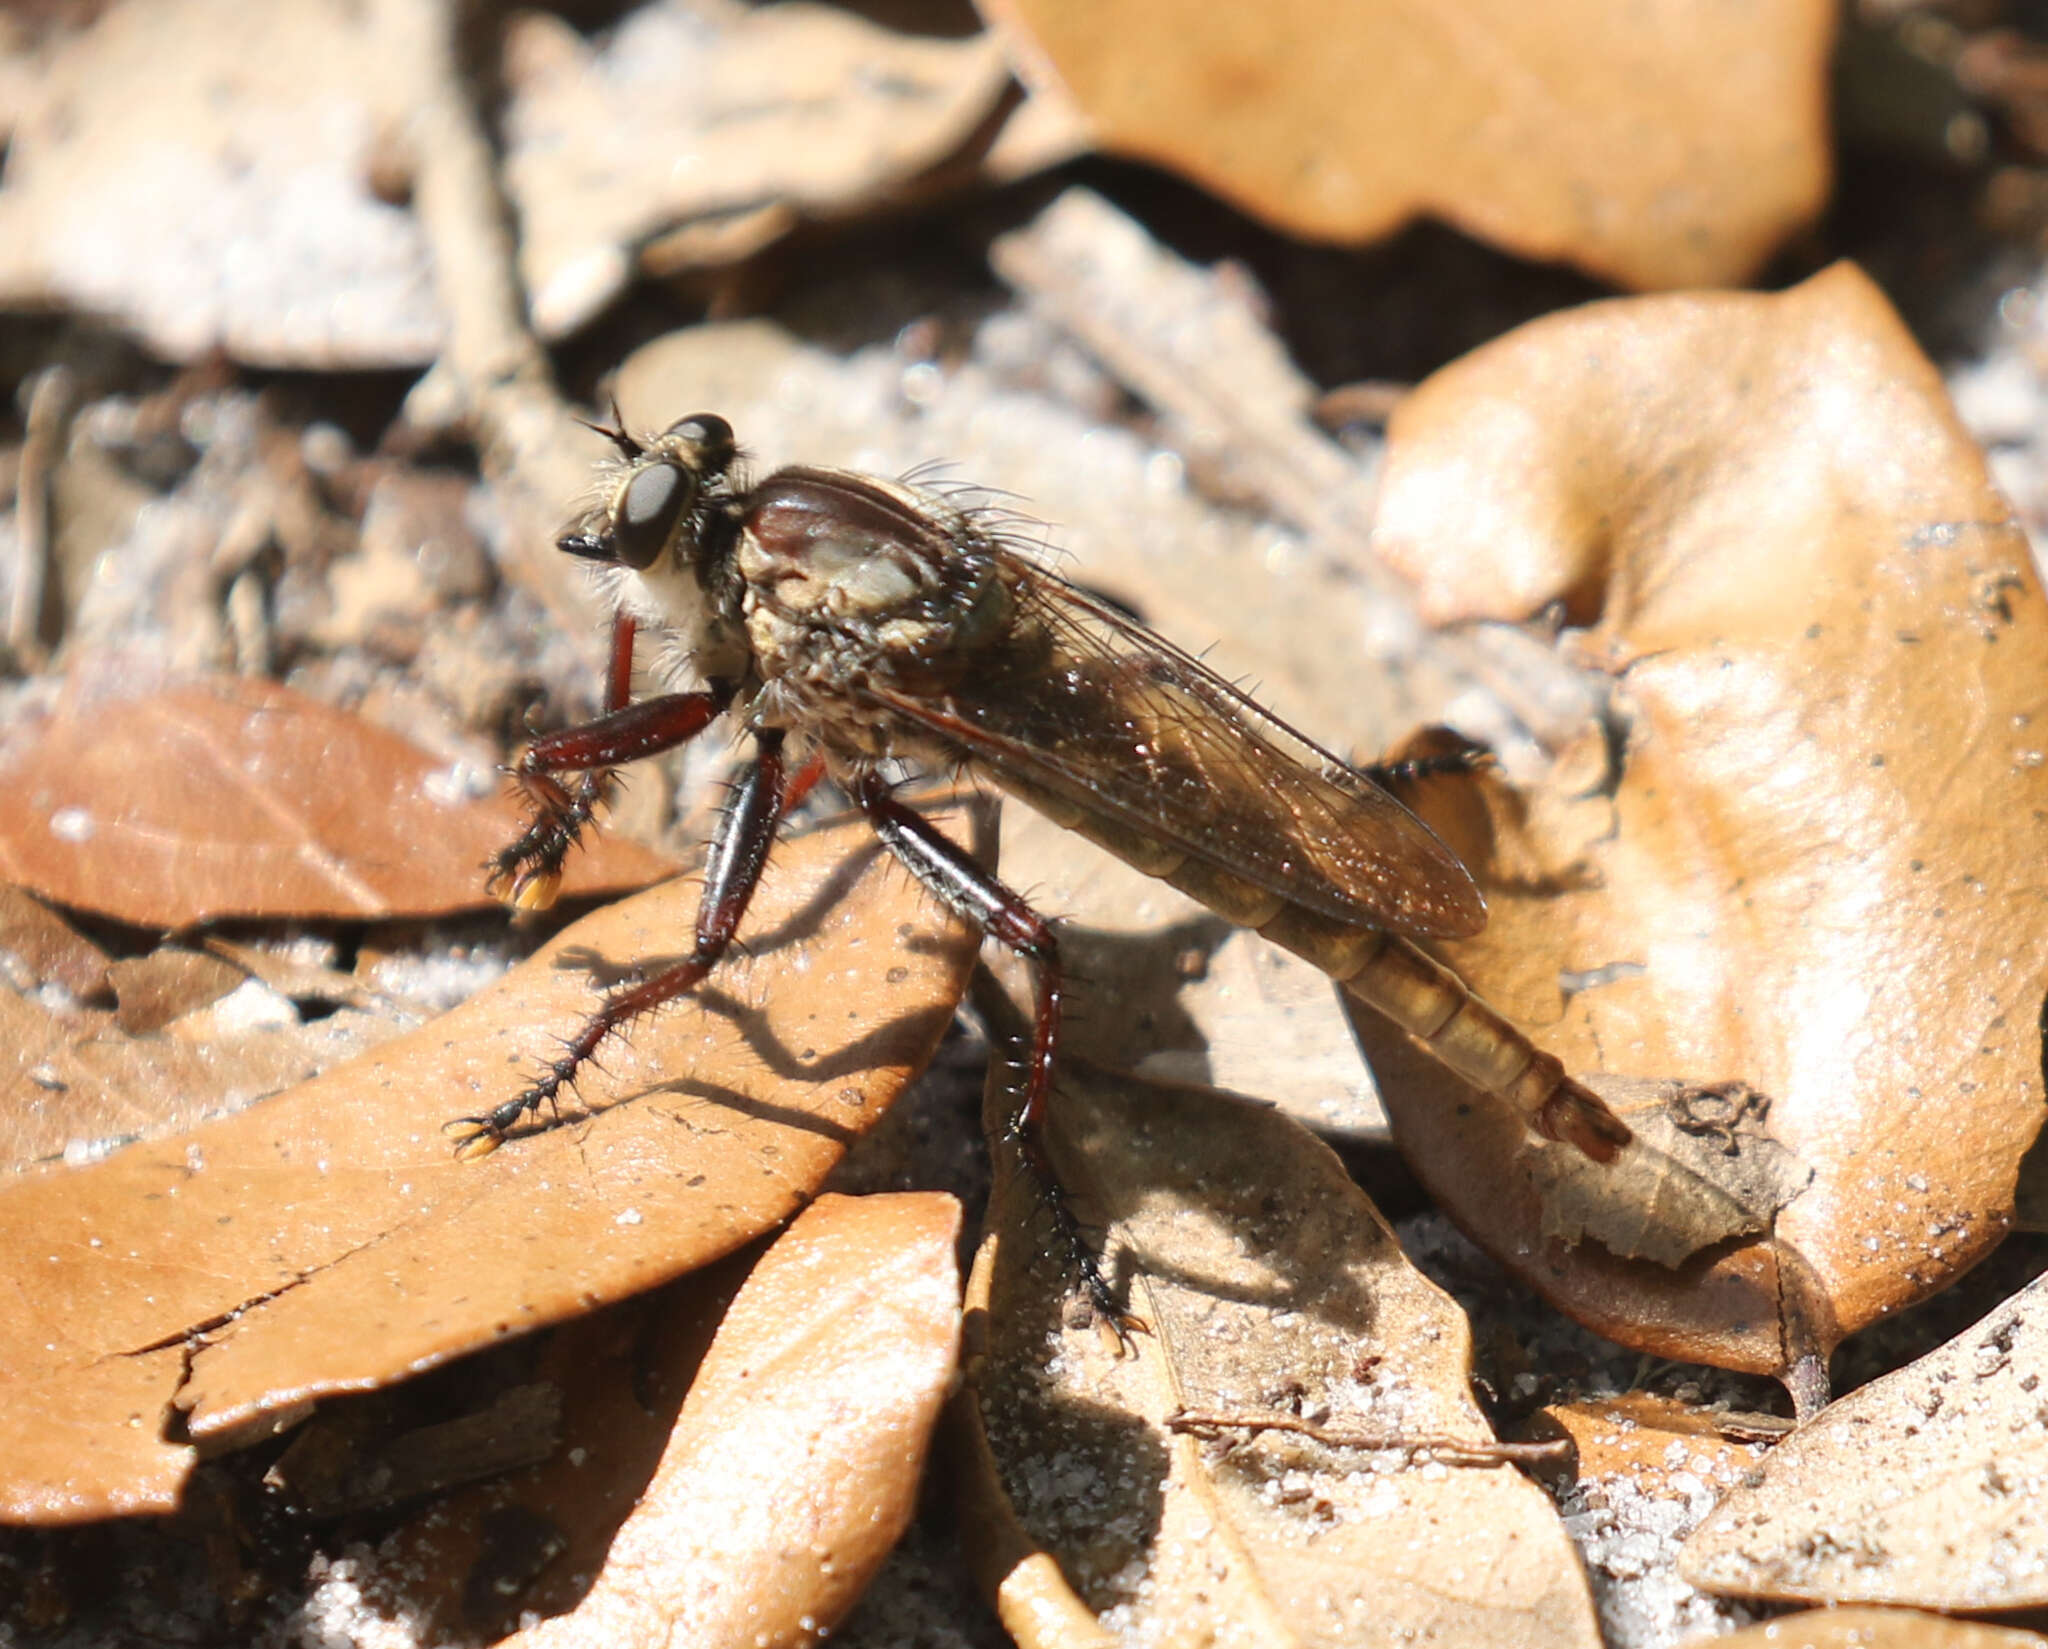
[981,0,1835,287]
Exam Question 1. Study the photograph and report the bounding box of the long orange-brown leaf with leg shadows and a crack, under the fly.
[0,798,975,1522]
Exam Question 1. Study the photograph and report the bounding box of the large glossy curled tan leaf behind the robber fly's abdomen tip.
[1360,266,2048,1372]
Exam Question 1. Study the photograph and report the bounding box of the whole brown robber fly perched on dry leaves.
[460,412,1630,1319]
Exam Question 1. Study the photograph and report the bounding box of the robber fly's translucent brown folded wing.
[866,551,1487,938]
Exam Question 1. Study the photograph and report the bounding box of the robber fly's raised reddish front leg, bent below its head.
[487,682,733,910]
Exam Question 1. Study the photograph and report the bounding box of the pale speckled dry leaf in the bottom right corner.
[1681,1278,2048,1612]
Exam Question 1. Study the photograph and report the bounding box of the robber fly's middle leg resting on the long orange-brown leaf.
[444,731,786,1157]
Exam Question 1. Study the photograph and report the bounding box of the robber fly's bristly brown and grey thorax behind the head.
[737,469,1010,699]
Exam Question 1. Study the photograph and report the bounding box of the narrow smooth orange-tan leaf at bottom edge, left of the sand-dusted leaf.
[497,1192,961,1649]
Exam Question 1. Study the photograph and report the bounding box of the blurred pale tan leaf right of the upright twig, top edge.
[506,0,1010,337]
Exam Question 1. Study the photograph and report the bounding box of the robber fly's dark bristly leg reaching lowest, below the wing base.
[854,772,1145,1342]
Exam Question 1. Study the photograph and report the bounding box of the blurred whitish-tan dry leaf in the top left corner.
[0,0,444,369]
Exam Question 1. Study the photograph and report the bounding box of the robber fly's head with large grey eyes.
[557,412,739,574]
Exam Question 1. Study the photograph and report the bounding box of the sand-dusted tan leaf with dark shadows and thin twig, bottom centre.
[958,1061,1599,1649]
